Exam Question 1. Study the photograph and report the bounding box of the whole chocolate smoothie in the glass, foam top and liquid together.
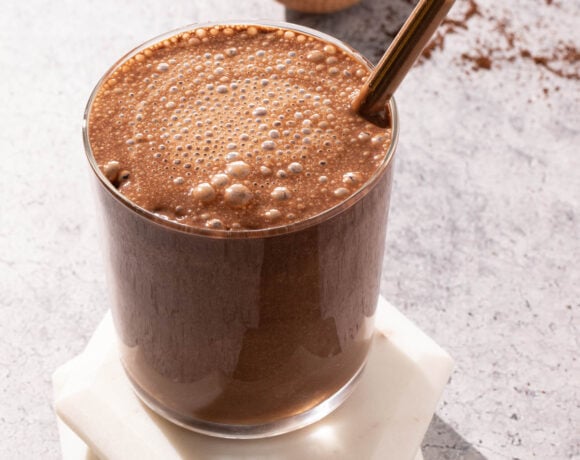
[85,25,393,435]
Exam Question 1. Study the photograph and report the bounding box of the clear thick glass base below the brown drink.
[128,364,365,439]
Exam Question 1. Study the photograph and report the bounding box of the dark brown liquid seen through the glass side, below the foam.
[91,24,392,425]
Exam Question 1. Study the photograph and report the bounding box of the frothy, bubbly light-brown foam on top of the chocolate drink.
[89,26,391,230]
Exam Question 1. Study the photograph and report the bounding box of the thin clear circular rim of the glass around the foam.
[82,20,399,239]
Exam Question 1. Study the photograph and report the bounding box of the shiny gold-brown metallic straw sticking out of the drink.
[353,0,454,126]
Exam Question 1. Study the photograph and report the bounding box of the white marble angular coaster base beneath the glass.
[53,298,453,460]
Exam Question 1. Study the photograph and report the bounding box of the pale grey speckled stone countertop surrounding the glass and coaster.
[0,0,580,460]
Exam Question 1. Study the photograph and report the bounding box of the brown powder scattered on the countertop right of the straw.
[419,0,580,86]
